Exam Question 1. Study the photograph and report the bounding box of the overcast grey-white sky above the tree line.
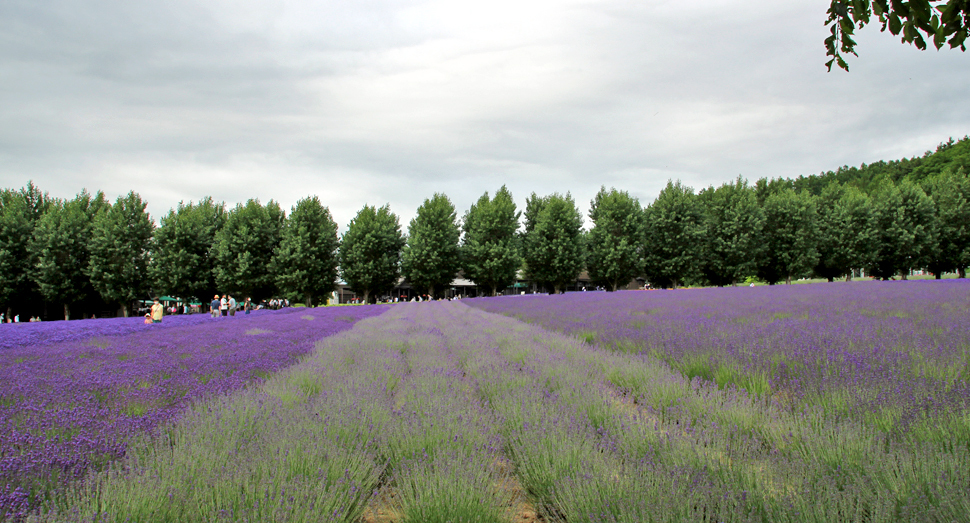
[0,0,970,230]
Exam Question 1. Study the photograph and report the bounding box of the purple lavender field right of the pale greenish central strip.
[469,280,970,437]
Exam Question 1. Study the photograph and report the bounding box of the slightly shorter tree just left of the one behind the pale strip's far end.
[340,205,406,303]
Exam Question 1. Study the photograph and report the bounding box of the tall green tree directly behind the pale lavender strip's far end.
[401,193,461,296]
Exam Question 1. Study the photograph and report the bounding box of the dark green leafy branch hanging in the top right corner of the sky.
[825,0,970,71]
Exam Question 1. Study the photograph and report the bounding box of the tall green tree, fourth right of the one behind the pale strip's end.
[644,180,705,289]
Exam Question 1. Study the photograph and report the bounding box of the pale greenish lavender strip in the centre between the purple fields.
[22,290,970,523]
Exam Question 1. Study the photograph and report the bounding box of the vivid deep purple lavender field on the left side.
[0,307,385,517]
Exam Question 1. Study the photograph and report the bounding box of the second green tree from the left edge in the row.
[31,191,111,320]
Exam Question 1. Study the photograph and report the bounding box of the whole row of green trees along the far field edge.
[0,138,970,319]
